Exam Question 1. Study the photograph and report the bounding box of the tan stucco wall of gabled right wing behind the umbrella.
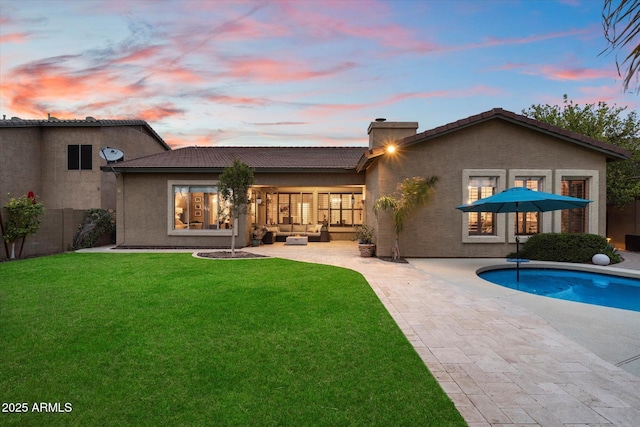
[367,120,606,257]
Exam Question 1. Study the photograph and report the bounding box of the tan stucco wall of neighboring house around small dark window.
[0,125,166,209]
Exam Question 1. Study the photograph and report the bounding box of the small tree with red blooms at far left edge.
[3,193,45,259]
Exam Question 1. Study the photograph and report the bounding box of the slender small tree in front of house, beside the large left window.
[218,159,254,256]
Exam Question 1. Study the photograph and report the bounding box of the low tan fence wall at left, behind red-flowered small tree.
[0,208,87,261]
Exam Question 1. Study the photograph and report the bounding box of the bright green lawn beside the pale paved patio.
[0,253,465,426]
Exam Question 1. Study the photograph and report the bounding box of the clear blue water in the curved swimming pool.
[478,268,640,312]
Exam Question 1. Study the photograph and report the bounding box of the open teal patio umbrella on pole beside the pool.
[456,187,591,281]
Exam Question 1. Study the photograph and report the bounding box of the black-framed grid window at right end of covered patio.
[318,193,364,227]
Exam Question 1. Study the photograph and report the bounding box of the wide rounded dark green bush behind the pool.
[508,233,622,264]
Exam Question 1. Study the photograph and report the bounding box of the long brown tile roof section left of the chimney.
[110,147,366,172]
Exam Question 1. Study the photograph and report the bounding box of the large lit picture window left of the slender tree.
[173,185,233,230]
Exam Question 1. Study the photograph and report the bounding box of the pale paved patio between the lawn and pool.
[86,241,640,427]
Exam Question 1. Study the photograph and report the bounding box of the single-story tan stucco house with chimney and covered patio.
[103,109,629,257]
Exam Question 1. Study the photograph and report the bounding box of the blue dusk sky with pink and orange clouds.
[0,0,640,148]
